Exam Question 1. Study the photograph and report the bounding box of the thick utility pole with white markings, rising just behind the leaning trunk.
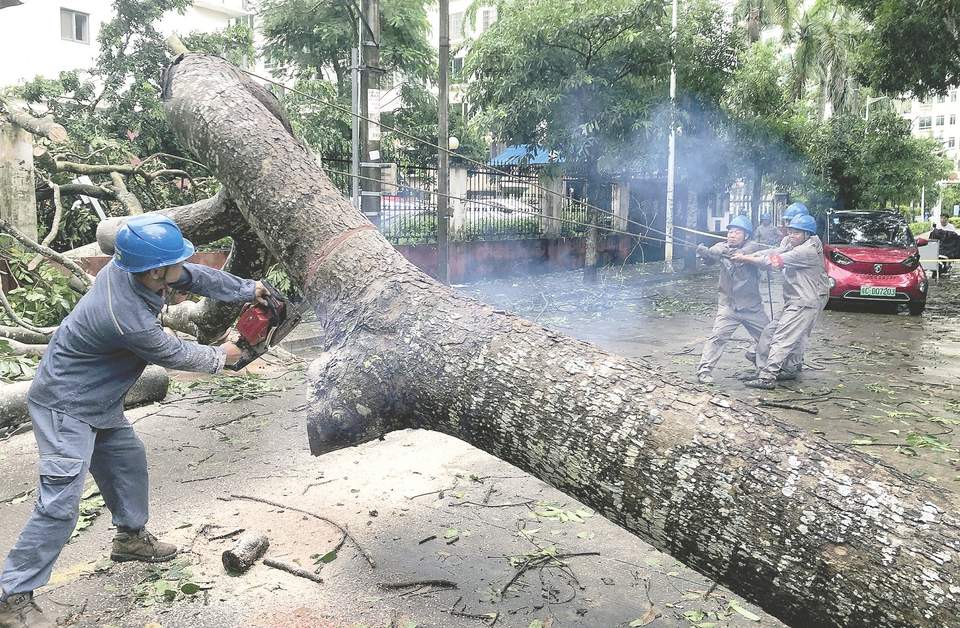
[360,0,381,228]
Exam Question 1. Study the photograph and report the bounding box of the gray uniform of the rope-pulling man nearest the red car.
[757,235,830,380]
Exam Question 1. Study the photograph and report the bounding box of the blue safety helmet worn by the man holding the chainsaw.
[113,214,194,273]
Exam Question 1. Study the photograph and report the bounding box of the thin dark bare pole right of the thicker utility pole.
[437,0,450,283]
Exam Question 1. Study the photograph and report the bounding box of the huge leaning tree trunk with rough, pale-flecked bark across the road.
[164,55,960,627]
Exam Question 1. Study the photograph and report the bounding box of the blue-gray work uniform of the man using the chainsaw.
[0,262,256,596]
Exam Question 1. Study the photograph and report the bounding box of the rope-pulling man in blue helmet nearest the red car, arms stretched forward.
[734,214,830,390]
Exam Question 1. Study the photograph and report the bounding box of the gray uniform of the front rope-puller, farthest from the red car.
[697,242,770,373]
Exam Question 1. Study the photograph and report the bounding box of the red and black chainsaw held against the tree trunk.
[226,280,303,371]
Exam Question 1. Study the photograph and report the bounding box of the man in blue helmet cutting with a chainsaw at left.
[0,214,267,626]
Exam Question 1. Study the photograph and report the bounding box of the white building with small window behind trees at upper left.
[0,0,250,87]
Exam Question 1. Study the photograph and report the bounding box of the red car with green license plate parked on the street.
[823,211,927,316]
